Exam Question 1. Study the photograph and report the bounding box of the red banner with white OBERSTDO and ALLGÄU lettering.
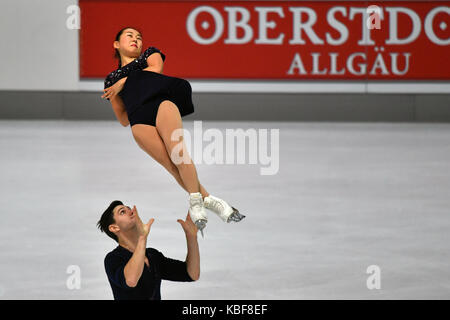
[79,0,450,80]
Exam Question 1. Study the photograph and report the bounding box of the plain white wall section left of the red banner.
[0,0,79,91]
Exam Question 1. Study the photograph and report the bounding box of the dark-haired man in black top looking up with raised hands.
[97,200,200,300]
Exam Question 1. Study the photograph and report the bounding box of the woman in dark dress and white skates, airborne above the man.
[102,27,245,236]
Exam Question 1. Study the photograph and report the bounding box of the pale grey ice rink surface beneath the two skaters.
[0,120,450,300]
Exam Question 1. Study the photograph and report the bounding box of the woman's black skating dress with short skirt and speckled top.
[105,47,194,126]
